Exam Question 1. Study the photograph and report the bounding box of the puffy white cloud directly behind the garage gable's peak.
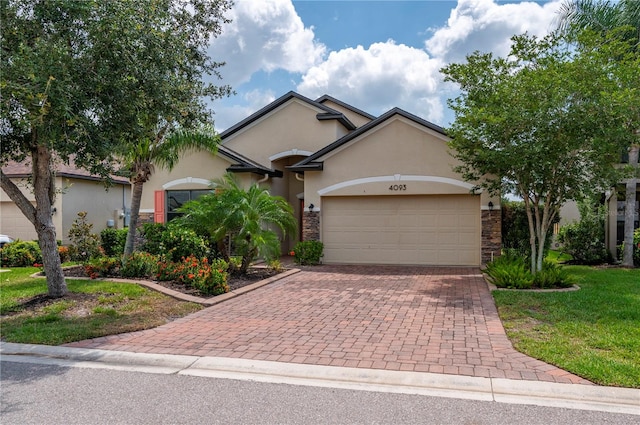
[297,40,444,122]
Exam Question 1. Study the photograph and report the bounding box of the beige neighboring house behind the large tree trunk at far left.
[0,162,131,244]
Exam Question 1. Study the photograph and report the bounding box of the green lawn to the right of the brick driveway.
[493,266,640,388]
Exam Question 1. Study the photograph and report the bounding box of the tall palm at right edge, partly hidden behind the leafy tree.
[558,0,640,267]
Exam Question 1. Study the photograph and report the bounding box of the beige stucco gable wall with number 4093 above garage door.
[305,117,500,208]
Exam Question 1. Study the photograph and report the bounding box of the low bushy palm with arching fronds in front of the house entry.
[176,173,297,274]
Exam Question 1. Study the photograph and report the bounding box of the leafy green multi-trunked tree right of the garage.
[442,33,638,273]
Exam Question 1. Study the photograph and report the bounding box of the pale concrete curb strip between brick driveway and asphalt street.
[0,342,640,415]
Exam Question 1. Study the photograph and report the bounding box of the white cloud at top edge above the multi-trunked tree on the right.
[425,0,561,62]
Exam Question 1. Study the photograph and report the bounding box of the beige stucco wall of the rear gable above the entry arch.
[223,98,346,167]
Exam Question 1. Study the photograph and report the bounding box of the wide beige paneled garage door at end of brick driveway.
[321,195,481,266]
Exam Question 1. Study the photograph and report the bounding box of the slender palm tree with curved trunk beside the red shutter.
[122,127,220,258]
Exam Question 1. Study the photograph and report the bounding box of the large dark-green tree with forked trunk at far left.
[0,0,231,296]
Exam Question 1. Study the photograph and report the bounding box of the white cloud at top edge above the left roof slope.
[209,0,326,87]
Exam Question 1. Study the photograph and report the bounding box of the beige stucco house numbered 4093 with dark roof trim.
[140,92,501,266]
